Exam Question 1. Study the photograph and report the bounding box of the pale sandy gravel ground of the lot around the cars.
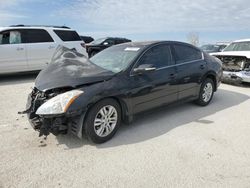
[0,75,250,188]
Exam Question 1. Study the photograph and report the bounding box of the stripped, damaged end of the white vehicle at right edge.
[215,55,250,83]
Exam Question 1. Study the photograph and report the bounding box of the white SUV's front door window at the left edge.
[0,31,22,44]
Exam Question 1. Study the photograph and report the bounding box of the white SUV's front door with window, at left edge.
[0,30,28,73]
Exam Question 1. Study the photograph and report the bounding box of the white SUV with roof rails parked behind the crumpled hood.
[0,25,88,74]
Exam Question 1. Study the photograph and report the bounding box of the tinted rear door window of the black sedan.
[174,44,202,64]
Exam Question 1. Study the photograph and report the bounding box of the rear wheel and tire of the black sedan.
[195,78,214,106]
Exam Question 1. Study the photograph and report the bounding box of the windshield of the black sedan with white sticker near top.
[90,45,141,73]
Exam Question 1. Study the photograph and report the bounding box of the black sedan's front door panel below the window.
[128,67,178,113]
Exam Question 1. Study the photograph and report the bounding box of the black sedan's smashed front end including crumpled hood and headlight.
[23,46,114,138]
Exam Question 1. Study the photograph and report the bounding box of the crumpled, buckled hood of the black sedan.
[35,47,114,91]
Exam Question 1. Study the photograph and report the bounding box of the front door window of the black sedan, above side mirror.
[137,45,173,68]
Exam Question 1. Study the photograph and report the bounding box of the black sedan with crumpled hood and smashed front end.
[23,41,222,143]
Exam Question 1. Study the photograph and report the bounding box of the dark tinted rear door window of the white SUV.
[22,29,54,43]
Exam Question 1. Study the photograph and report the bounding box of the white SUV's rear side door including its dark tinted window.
[22,29,56,70]
